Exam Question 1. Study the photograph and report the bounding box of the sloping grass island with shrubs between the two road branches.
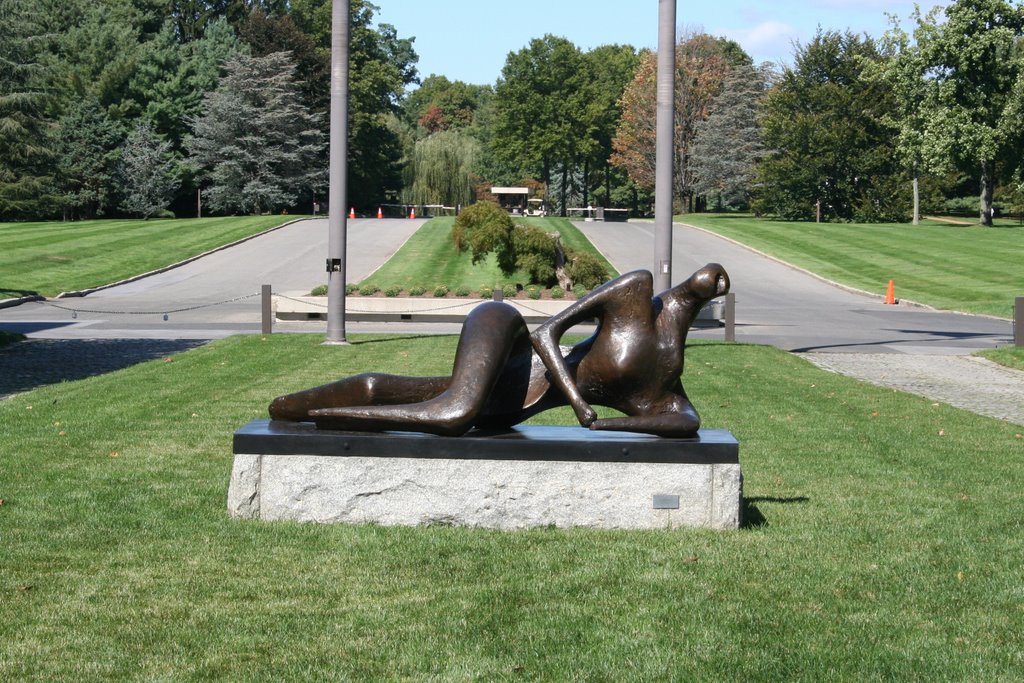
[360,217,617,291]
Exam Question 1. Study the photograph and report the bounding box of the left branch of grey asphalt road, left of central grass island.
[0,219,424,339]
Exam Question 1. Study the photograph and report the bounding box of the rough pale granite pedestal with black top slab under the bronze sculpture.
[227,420,742,529]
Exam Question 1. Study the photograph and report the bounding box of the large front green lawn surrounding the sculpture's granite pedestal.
[0,335,1024,681]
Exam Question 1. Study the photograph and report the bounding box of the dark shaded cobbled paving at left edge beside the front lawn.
[0,339,206,398]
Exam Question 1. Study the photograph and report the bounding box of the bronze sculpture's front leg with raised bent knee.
[309,302,530,435]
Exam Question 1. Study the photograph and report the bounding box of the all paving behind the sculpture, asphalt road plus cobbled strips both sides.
[0,219,1024,423]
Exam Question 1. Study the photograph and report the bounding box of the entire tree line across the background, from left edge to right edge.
[0,0,1024,224]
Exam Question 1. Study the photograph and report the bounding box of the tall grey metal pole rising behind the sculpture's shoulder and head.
[654,0,676,292]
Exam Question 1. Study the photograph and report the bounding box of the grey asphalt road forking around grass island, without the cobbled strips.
[0,219,1012,354]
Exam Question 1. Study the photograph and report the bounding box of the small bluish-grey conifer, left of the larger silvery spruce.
[118,123,181,218]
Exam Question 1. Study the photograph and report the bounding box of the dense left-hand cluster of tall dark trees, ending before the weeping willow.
[0,0,417,220]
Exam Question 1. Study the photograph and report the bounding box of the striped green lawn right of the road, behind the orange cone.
[676,214,1024,317]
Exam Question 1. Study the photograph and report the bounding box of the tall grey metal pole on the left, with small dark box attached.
[327,0,349,344]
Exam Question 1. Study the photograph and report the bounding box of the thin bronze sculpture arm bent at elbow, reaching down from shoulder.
[530,270,653,427]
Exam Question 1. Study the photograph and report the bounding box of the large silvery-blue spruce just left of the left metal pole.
[186,52,326,214]
